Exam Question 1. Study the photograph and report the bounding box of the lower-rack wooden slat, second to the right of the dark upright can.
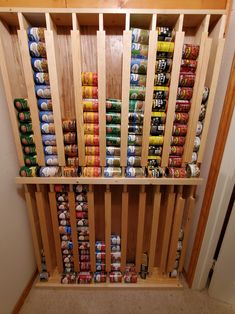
[160,186,175,273]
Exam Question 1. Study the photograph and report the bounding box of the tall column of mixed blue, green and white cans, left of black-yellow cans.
[126,28,149,178]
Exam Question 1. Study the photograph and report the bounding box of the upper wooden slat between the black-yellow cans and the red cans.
[161,14,184,167]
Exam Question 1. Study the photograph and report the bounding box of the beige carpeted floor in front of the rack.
[20,288,235,314]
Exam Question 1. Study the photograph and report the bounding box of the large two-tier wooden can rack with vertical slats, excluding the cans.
[0,8,226,287]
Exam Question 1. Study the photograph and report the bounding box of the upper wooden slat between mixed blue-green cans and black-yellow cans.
[141,14,157,167]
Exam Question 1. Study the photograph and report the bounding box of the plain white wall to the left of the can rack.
[0,77,35,314]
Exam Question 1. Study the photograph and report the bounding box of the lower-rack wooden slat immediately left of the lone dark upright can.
[135,185,146,273]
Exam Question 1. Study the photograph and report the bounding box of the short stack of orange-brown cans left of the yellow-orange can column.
[62,119,81,177]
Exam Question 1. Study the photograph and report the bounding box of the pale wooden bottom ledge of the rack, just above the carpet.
[35,268,183,289]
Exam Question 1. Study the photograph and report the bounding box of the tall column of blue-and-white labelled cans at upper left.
[28,27,58,177]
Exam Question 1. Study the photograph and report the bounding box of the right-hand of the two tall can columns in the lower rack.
[74,185,92,284]
